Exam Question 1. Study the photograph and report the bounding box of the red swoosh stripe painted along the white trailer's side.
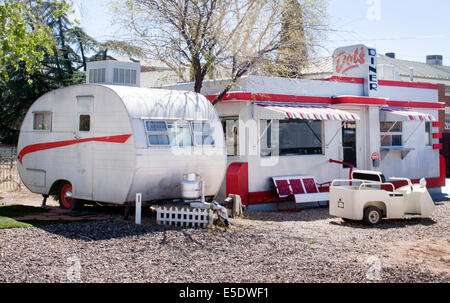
[17,134,132,164]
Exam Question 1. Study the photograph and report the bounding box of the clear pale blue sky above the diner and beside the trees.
[74,0,450,66]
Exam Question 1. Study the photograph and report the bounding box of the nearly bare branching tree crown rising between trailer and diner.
[110,0,324,103]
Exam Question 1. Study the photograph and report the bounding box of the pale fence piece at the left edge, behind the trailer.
[0,147,22,191]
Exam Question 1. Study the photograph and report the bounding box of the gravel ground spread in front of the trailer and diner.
[0,191,450,283]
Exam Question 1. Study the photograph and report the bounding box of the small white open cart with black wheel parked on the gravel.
[330,170,435,225]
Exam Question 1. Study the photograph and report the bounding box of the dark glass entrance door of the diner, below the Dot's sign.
[340,111,366,179]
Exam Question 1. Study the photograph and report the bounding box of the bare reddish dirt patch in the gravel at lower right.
[386,238,450,274]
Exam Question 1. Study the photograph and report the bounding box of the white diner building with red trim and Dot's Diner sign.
[167,45,445,210]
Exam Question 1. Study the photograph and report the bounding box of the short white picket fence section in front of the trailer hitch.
[156,206,214,228]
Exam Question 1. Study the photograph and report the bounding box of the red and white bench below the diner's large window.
[272,175,330,211]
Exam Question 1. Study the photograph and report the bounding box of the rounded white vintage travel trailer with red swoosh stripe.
[18,84,226,208]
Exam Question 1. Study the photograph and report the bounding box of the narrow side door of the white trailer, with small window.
[73,96,94,200]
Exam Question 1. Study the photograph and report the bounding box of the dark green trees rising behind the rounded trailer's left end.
[0,0,100,144]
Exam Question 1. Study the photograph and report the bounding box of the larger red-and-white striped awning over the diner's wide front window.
[255,103,361,121]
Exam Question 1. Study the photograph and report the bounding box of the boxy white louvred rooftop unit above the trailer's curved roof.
[86,60,141,87]
